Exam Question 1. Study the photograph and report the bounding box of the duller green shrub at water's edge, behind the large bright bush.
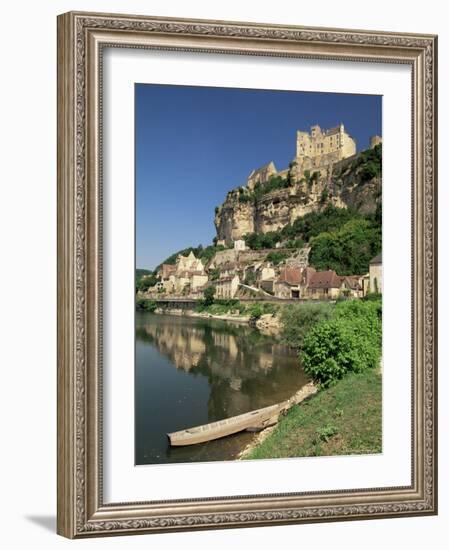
[280,304,333,349]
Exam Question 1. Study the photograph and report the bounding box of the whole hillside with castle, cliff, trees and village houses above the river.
[138,124,382,300]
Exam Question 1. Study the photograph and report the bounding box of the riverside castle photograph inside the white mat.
[134,83,383,466]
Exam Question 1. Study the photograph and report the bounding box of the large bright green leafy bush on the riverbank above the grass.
[300,300,382,387]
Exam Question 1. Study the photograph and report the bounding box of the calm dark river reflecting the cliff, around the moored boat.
[135,312,307,465]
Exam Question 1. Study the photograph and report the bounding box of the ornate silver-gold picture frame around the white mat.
[57,12,437,538]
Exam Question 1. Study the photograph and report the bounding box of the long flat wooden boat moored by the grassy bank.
[167,401,289,447]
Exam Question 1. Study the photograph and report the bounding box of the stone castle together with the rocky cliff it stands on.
[214,124,382,246]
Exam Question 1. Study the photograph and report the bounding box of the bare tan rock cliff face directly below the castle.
[214,155,381,244]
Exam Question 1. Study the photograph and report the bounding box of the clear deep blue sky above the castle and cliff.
[135,84,381,269]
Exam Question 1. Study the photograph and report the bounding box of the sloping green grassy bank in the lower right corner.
[244,369,382,460]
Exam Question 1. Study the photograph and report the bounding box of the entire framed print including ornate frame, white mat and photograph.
[58,12,437,538]
